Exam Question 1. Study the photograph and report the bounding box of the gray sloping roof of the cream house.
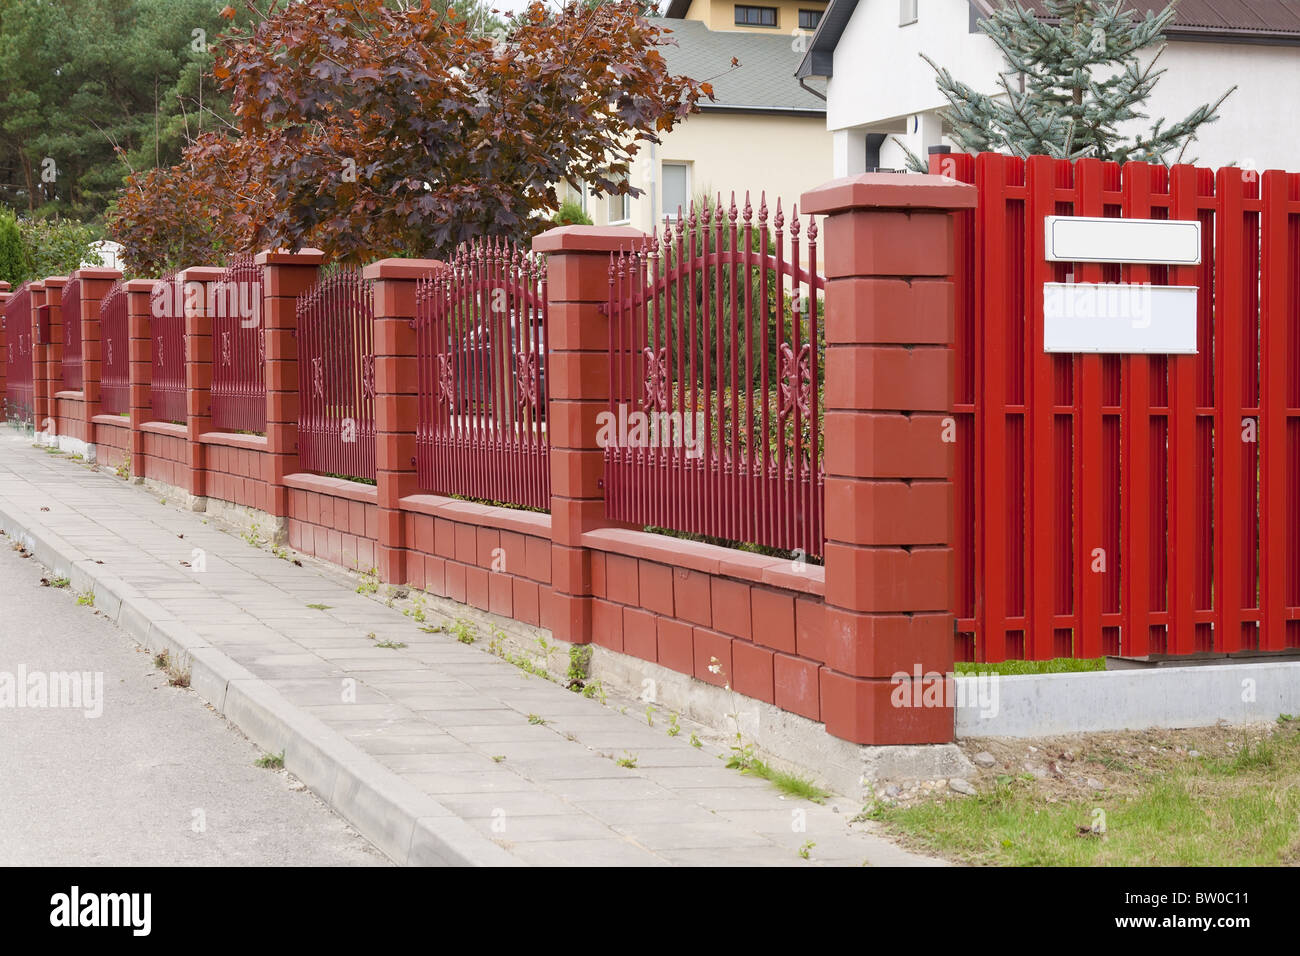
[649,17,826,116]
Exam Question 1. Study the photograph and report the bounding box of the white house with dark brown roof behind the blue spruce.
[796,0,1300,176]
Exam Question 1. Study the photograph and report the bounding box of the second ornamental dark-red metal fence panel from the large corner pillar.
[416,241,551,510]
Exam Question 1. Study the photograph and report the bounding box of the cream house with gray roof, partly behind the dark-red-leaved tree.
[577,0,832,232]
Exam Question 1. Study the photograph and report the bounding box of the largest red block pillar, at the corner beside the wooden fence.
[801,173,975,744]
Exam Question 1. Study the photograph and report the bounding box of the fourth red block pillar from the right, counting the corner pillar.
[257,248,325,518]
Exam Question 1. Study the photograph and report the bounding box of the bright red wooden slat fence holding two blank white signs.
[931,155,1300,661]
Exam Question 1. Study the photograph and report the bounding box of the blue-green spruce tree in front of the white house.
[909,0,1236,170]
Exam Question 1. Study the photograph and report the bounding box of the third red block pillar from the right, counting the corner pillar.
[365,259,441,584]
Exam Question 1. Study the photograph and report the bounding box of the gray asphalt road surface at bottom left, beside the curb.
[0,537,389,866]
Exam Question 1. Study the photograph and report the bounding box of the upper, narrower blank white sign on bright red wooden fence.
[1044,216,1201,265]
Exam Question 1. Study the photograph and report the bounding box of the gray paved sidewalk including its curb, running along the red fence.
[0,427,935,866]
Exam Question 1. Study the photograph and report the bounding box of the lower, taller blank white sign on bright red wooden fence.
[1043,282,1197,355]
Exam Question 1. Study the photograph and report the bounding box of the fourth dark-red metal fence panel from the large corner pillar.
[211,256,267,432]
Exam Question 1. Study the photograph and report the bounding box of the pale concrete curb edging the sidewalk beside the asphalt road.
[0,494,524,866]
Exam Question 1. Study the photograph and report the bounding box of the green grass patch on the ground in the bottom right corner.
[865,722,1300,866]
